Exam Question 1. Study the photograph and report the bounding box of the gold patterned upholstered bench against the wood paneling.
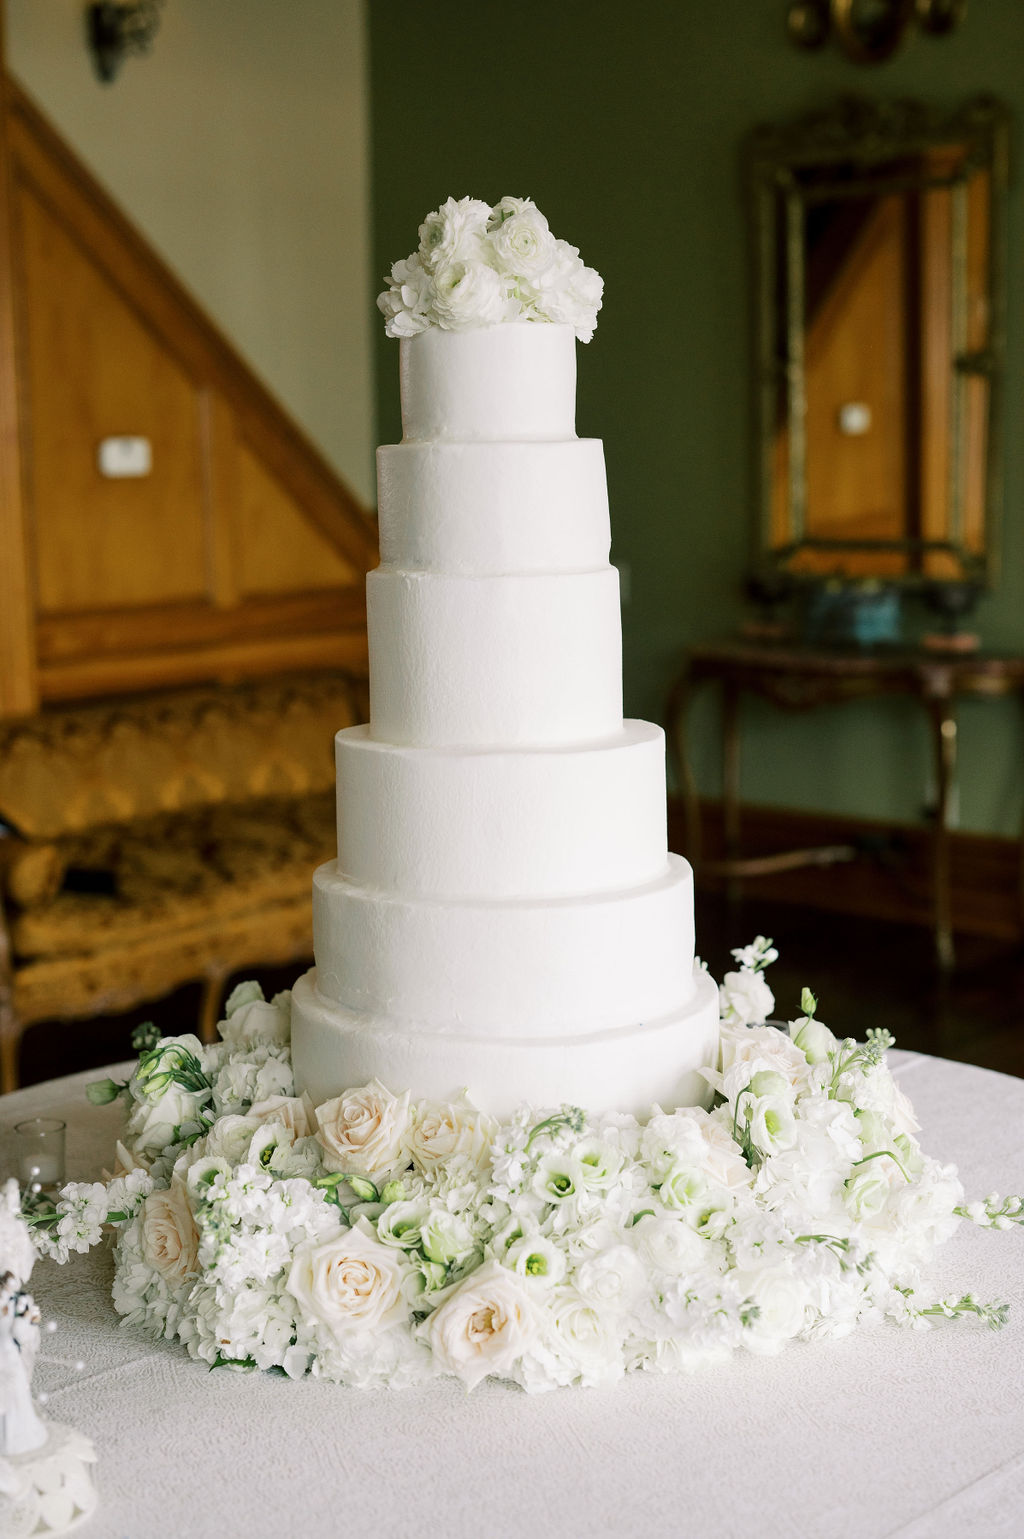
[0,673,366,1091]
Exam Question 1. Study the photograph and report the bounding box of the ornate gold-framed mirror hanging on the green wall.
[745,98,1009,586]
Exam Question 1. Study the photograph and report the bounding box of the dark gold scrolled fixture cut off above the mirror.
[785,0,967,65]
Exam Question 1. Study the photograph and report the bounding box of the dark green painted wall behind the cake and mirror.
[370,0,1024,833]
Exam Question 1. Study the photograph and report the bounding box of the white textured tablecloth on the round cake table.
[0,1053,1024,1539]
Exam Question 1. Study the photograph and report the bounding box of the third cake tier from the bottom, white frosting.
[336,722,667,897]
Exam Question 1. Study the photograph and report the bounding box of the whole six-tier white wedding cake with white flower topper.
[293,199,719,1116]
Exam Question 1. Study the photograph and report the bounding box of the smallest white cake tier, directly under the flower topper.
[399,320,576,443]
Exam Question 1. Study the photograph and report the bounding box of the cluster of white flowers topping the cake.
[377,197,604,342]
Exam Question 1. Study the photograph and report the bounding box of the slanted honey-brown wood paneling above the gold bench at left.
[0,73,376,713]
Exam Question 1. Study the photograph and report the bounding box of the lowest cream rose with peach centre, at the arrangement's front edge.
[428,1260,537,1390]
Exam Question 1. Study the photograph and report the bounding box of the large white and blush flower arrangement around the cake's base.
[25,937,1024,1391]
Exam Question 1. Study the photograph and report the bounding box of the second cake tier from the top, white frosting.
[377,439,611,576]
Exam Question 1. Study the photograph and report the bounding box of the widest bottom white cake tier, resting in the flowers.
[291,968,719,1117]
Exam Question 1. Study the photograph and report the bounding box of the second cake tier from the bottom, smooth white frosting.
[313,856,693,1037]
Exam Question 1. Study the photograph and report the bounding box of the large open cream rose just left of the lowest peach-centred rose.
[288,1219,408,1336]
